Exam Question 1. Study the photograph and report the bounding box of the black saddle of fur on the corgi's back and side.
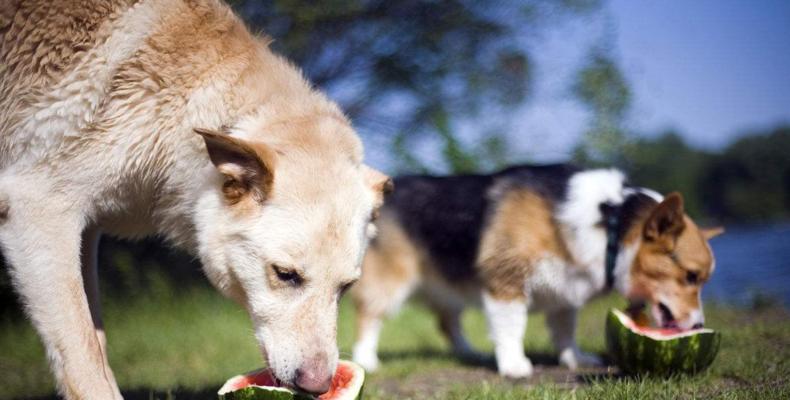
[386,164,580,282]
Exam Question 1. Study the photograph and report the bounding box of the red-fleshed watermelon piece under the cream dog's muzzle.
[217,360,365,400]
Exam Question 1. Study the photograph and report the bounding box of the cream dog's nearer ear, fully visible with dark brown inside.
[195,128,275,204]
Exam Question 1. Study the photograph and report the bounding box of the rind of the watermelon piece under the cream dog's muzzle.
[217,360,365,400]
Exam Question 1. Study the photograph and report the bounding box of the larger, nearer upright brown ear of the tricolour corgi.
[643,192,686,250]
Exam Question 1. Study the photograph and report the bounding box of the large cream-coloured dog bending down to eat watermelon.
[0,0,387,400]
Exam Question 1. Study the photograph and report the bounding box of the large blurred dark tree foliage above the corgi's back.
[232,0,599,170]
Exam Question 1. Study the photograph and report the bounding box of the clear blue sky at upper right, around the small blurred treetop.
[492,0,790,161]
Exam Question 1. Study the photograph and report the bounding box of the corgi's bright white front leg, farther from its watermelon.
[483,292,532,378]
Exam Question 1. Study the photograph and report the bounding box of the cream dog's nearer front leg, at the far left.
[0,191,121,400]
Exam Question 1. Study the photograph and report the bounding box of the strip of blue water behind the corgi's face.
[702,223,790,306]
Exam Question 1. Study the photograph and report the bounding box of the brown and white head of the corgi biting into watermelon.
[625,193,723,329]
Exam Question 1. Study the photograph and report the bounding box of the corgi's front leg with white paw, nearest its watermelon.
[546,308,601,370]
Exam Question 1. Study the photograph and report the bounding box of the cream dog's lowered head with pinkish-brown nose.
[196,115,391,393]
